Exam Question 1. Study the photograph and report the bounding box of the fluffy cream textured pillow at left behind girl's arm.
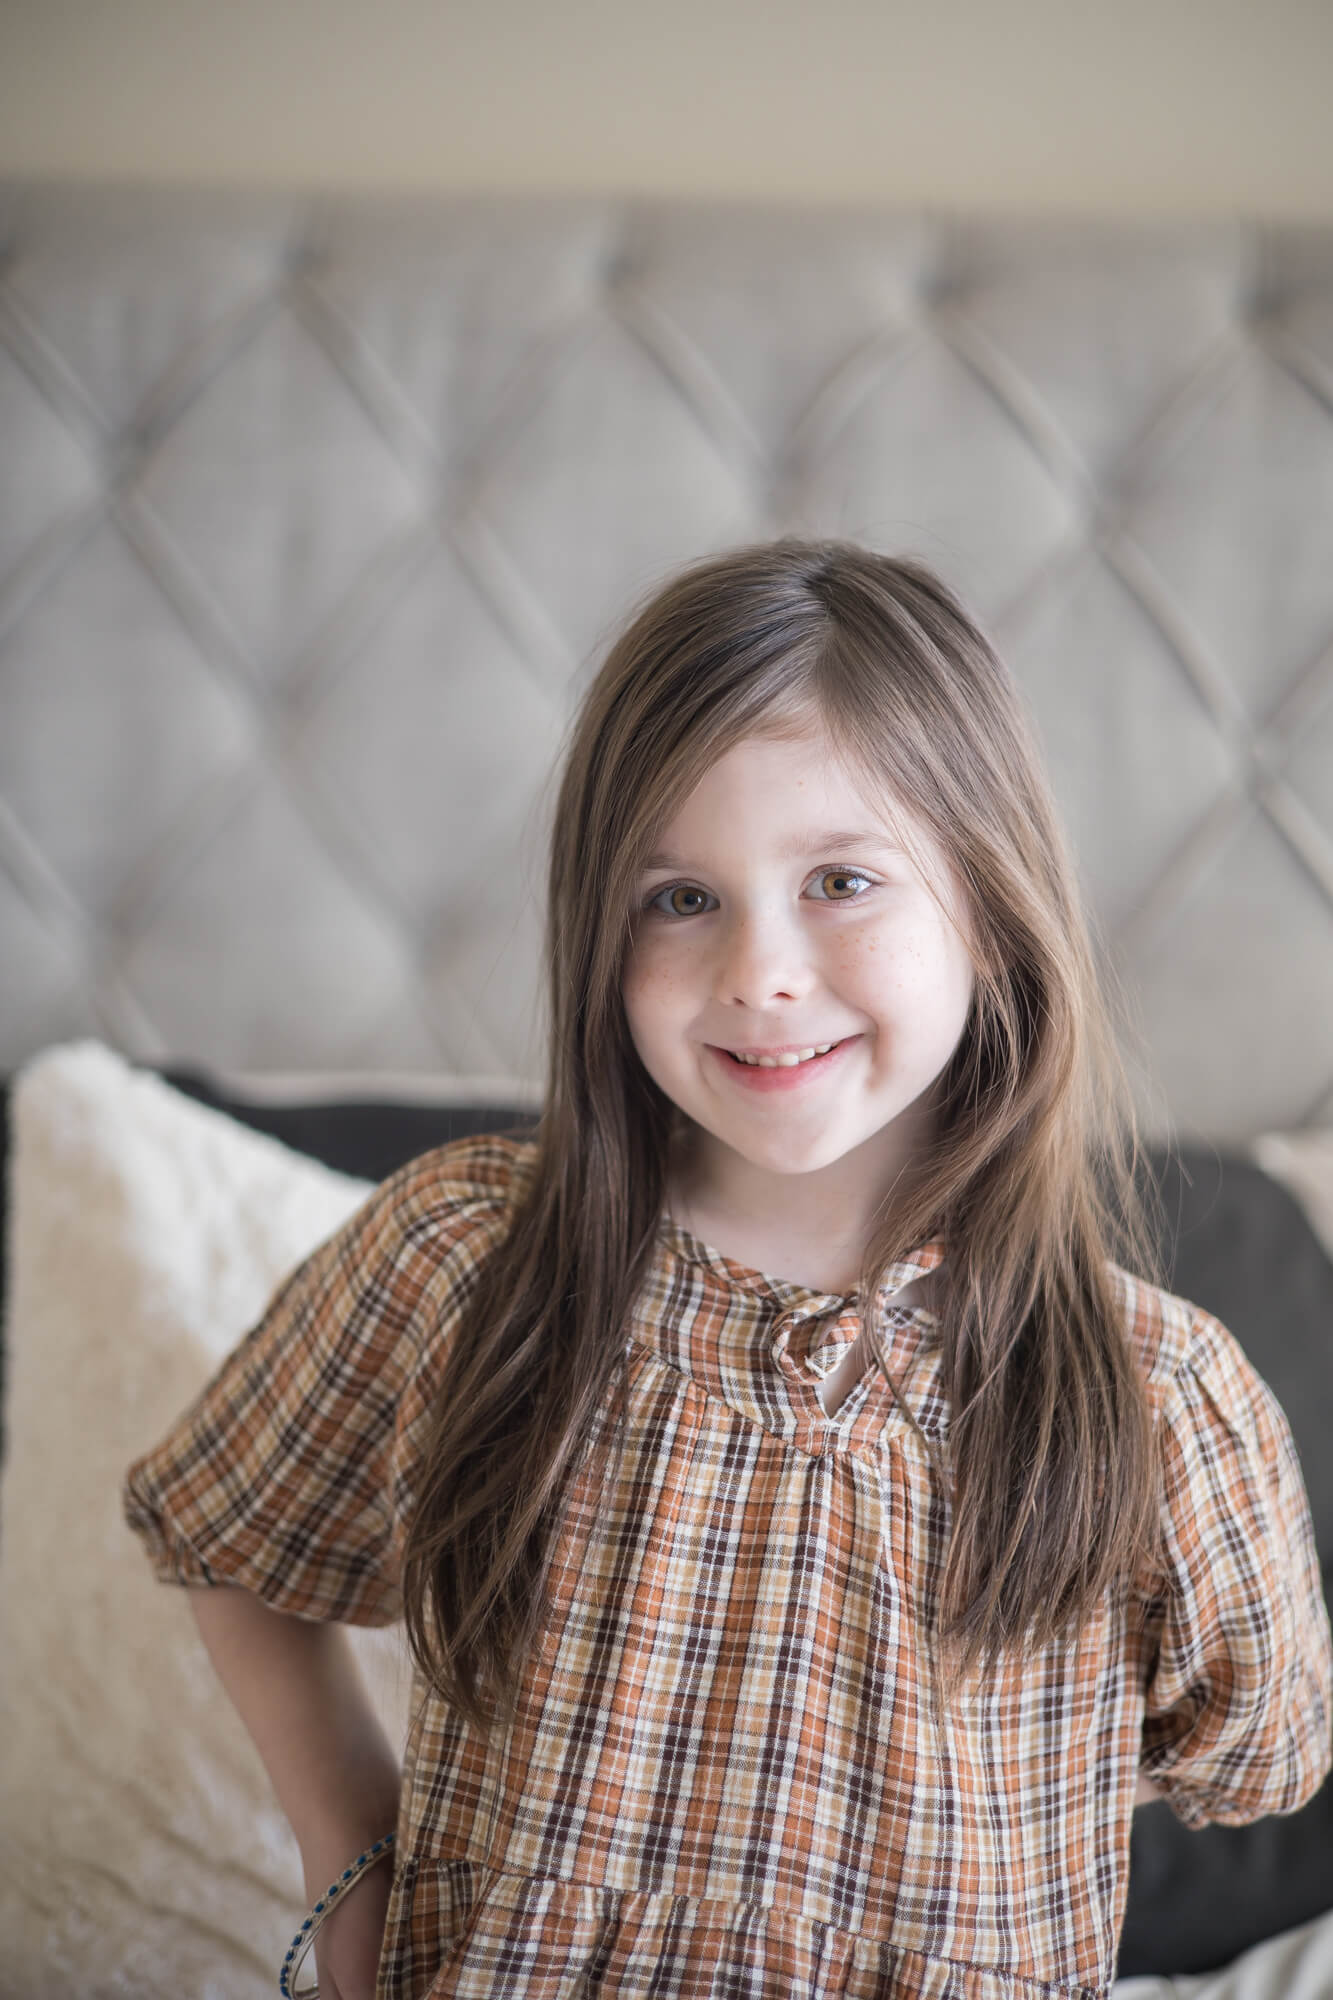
[0,1042,410,2000]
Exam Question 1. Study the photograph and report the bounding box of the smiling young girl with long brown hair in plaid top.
[126,540,1333,2000]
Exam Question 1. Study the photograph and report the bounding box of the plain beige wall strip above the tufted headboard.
[0,0,1333,218]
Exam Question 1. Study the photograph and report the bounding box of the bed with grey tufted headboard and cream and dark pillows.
[0,184,1333,2000]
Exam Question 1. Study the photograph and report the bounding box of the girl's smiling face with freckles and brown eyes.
[622,718,973,1198]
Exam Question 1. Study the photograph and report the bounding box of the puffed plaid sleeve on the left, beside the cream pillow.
[122,1138,518,1626]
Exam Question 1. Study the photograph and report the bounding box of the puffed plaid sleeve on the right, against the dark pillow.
[1141,1312,1333,1826]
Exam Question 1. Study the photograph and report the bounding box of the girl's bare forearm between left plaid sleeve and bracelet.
[186,1584,400,1872]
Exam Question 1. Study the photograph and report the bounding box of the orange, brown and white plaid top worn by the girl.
[124,1138,1333,2000]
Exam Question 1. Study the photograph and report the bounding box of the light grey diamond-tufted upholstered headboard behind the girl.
[0,184,1333,1142]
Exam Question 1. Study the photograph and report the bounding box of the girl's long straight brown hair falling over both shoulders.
[404,538,1159,1728]
